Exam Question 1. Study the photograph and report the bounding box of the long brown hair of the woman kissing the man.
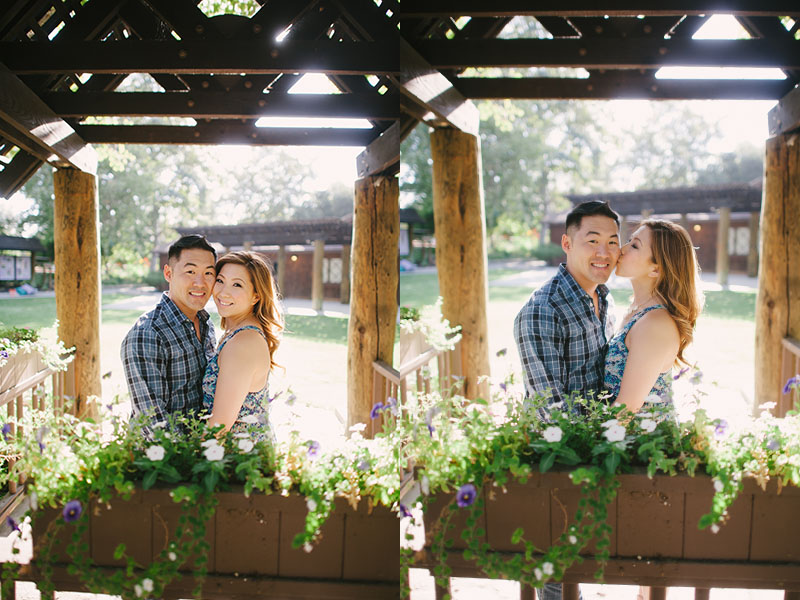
[641,219,703,365]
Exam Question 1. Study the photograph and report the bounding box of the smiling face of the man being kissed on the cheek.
[561,215,619,293]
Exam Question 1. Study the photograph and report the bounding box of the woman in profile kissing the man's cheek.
[605,219,702,420]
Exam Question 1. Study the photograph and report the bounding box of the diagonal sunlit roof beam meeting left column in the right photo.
[394,37,480,135]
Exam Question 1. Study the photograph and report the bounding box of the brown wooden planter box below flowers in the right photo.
[417,472,800,590]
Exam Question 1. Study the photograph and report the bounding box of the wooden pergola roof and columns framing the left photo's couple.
[0,0,400,423]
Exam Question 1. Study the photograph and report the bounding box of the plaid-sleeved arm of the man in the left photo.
[120,328,169,425]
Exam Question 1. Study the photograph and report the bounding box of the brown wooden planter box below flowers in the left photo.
[32,489,400,599]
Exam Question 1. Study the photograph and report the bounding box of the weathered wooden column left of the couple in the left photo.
[53,167,102,417]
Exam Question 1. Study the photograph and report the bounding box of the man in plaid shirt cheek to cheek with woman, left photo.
[121,234,217,426]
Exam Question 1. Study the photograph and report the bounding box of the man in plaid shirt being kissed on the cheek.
[514,201,620,600]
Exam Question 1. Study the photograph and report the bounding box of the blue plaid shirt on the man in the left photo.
[120,292,216,424]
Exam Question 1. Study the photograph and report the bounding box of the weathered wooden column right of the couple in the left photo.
[347,177,400,427]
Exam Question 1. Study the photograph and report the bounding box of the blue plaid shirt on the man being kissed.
[514,264,614,408]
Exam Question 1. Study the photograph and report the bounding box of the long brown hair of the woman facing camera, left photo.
[214,250,283,369]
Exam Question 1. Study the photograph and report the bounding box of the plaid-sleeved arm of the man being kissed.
[514,304,567,404]
